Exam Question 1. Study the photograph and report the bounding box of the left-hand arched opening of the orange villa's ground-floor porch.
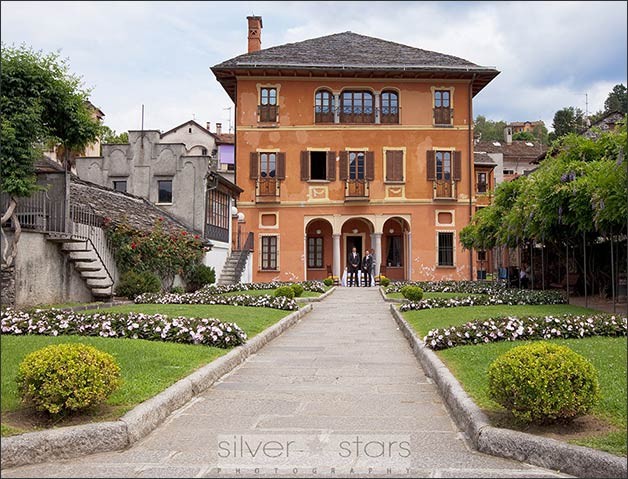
[305,218,333,281]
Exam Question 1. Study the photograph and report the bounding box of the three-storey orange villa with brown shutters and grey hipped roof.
[212,17,499,281]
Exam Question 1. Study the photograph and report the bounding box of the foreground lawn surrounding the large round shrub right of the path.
[437,336,627,456]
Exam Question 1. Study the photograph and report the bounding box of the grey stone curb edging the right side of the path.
[390,304,628,478]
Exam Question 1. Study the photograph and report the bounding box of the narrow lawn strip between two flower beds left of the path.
[94,304,293,338]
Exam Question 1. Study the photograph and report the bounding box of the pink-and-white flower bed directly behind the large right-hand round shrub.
[423,313,628,350]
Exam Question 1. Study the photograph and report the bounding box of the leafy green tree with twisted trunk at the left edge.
[0,44,100,268]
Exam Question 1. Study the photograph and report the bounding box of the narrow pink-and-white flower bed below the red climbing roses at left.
[135,288,299,311]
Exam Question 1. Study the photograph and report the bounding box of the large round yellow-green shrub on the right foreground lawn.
[488,342,600,424]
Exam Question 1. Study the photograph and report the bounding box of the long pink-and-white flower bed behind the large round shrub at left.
[2,308,247,348]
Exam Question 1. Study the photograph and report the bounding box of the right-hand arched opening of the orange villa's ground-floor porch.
[380,217,411,281]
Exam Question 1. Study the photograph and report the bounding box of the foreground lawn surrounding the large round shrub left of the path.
[0,335,229,435]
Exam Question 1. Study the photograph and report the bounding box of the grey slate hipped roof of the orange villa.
[212,32,499,98]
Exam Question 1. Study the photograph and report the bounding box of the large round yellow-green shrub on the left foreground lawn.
[16,343,120,414]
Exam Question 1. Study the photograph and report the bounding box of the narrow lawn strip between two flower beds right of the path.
[403,304,597,338]
